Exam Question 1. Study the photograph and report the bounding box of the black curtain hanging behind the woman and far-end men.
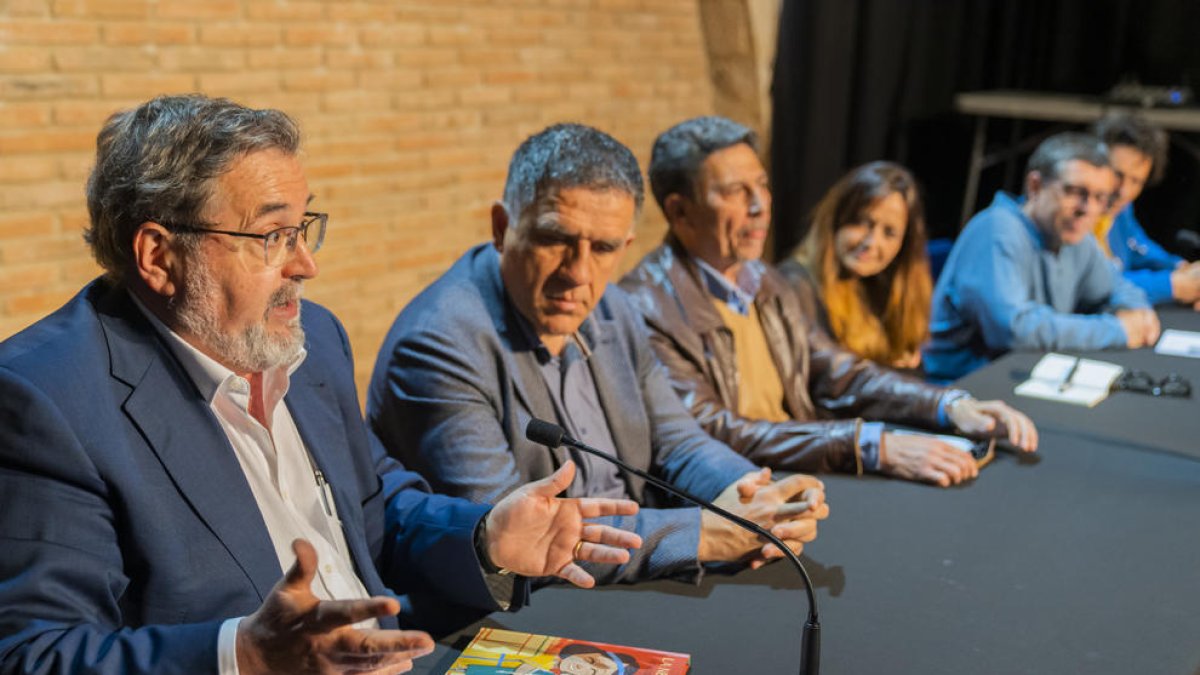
[770,0,1200,257]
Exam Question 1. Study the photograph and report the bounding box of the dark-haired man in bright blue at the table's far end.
[1093,113,1200,310]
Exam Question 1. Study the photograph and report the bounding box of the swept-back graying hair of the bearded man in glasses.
[84,94,300,283]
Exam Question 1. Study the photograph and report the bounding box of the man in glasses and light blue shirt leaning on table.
[925,133,1159,380]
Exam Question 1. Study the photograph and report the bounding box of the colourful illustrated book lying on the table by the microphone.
[446,628,691,675]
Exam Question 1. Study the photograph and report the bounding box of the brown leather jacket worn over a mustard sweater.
[620,235,947,472]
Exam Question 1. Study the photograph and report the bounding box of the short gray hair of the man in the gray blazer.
[504,124,644,225]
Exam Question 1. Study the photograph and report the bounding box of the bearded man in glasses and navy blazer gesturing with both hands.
[0,95,640,675]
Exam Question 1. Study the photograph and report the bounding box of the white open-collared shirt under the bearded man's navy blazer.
[131,293,378,675]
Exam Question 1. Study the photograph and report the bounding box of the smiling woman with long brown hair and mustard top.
[780,162,932,369]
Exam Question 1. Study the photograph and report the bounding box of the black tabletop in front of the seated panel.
[416,307,1200,675]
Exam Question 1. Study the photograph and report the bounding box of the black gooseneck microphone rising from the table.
[526,417,821,675]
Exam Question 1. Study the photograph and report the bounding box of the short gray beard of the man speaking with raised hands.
[175,258,305,372]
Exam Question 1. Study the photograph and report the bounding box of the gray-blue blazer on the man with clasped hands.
[367,244,755,583]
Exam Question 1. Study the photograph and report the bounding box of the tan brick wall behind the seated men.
[0,0,713,396]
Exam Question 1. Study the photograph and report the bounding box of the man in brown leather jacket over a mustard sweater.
[620,117,1037,486]
